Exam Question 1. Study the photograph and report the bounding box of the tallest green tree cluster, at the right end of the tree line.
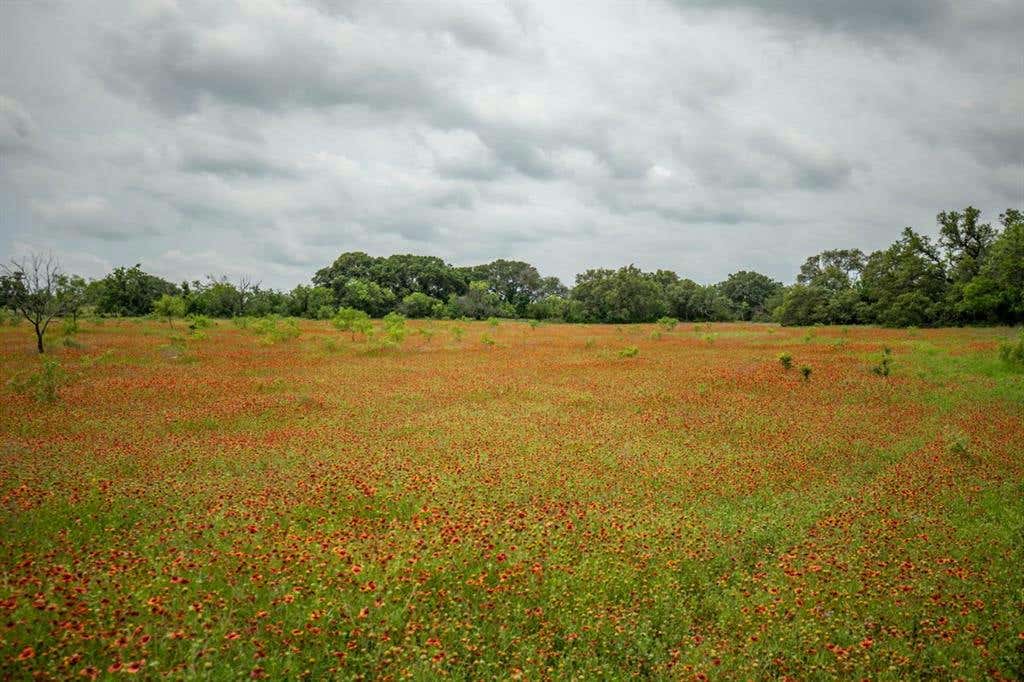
[774,207,1024,327]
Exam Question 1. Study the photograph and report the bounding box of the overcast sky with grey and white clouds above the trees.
[0,0,1024,289]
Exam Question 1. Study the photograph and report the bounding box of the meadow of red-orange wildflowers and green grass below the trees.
[0,319,1024,680]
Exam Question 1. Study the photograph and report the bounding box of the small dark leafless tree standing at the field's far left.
[0,254,80,352]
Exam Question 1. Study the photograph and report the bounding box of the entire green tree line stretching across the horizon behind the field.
[0,201,1024,344]
